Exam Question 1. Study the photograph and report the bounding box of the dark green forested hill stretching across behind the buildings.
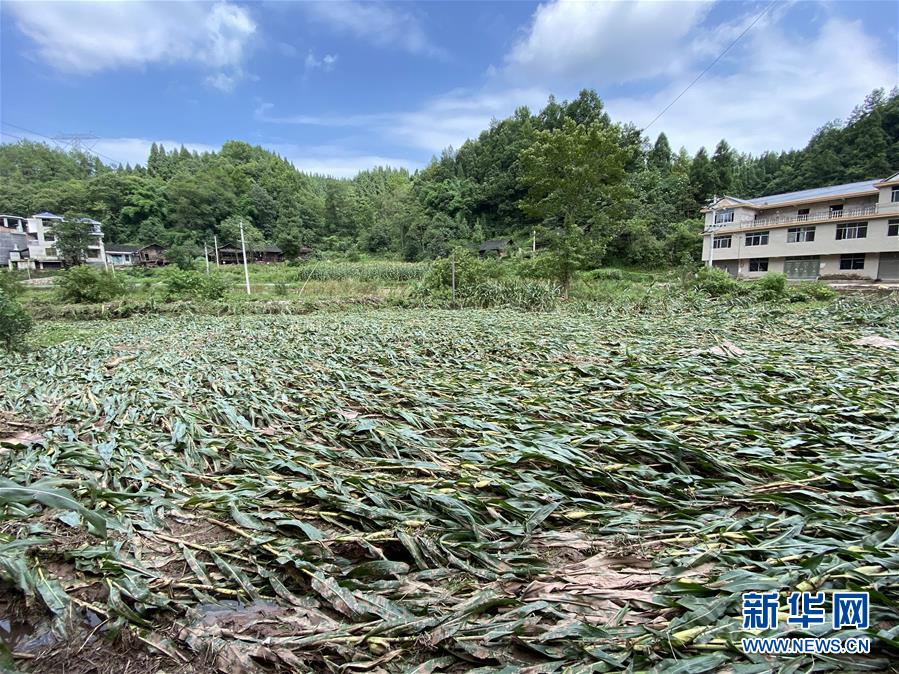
[0,90,899,264]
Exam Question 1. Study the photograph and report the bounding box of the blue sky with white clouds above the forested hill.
[0,0,899,176]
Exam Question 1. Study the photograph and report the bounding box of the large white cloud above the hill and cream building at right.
[606,18,897,154]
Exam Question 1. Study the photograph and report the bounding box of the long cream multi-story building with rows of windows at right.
[702,173,899,281]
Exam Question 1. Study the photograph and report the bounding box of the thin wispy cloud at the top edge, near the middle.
[300,0,445,56]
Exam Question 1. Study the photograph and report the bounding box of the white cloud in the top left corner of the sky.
[5,1,256,88]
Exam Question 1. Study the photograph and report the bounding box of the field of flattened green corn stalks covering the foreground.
[0,299,899,672]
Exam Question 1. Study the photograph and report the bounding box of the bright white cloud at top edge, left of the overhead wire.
[504,0,711,86]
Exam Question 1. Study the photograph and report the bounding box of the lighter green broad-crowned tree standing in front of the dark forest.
[521,119,630,293]
